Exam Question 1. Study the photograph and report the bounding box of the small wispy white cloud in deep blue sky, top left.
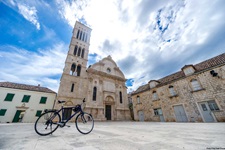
[18,3,40,30]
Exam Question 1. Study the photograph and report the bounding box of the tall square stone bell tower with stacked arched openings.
[57,21,91,106]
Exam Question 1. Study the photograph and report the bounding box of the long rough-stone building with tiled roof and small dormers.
[132,53,225,122]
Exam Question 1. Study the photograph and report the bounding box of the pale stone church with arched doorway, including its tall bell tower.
[56,21,131,121]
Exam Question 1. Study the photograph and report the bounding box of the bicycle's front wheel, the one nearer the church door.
[75,112,94,134]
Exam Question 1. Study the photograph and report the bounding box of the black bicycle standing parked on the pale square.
[34,98,94,136]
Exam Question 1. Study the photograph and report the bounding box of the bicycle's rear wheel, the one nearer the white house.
[34,111,61,136]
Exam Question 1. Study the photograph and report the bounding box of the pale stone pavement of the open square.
[0,122,225,150]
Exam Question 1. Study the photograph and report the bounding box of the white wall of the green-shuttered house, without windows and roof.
[0,87,56,123]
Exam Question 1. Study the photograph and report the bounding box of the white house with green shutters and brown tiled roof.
[0,82,56,123]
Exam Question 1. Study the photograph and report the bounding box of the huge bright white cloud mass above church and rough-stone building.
[54,0,225,92]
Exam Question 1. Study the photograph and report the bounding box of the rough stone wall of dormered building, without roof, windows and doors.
[132,66,225,122]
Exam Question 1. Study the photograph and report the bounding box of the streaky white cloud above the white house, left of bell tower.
[0,43,67,92]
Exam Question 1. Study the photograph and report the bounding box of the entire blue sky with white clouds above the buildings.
[0,0,225,92]
